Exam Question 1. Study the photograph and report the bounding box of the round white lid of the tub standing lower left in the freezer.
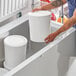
[4,35,27,47]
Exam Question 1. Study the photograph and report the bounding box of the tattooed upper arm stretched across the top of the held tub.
[33,0,66,12]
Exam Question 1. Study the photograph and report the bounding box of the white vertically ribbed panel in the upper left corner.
[0,0,28,22]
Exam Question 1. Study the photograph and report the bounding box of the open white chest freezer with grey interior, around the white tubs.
[0,15,76,76]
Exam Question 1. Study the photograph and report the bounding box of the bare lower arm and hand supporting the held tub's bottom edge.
[45,10,76,43]
